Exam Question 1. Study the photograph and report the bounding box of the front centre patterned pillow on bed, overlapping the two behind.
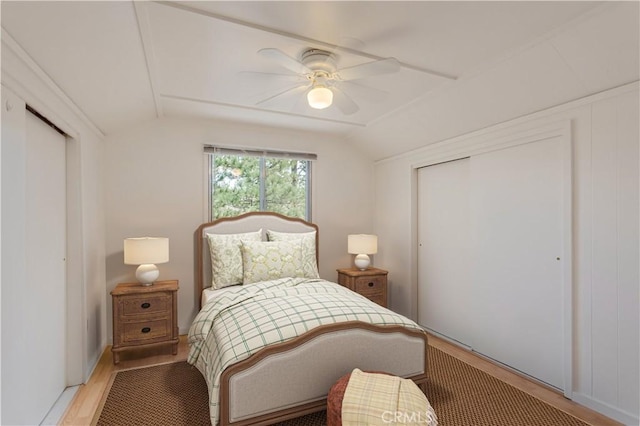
[242,241,302,284]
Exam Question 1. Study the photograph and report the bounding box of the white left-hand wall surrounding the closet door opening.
[1,32,106,423]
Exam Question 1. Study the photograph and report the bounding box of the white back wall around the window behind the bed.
[105,118,373,337]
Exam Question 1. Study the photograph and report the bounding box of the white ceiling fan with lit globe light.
[249,48,401,115]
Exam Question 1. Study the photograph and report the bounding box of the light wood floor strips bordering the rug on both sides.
[60,336,620,426]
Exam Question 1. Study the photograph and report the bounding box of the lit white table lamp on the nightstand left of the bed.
[124,237,169,286]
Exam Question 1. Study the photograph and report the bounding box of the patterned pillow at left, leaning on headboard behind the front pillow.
[207,229,262,289]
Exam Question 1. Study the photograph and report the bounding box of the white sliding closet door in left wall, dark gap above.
[26,112,67,422]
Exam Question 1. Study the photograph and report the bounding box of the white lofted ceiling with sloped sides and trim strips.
[1,1,640,159]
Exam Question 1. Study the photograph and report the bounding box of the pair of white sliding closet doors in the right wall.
[418,136,570,389]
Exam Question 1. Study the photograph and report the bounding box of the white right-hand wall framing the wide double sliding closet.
[374,83,640,424]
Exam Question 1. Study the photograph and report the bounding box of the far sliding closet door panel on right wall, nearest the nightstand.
[418,158,472,344]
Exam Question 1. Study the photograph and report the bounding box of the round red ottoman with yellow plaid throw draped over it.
[327,369,438,426]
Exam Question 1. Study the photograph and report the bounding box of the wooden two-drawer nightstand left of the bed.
[111,280,178,364]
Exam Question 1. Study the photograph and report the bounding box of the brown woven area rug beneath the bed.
[93,347,587,426]
